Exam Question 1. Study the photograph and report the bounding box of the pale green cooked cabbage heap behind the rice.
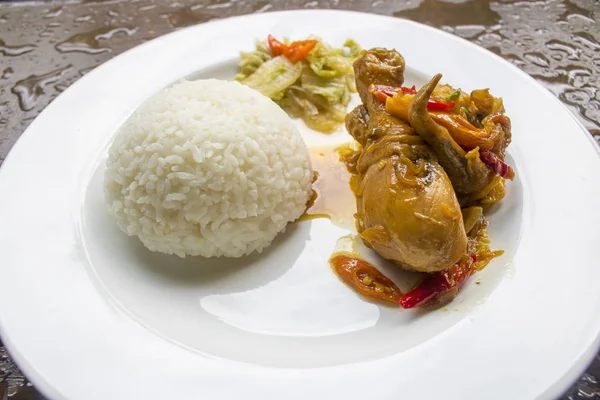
[235,38,361,133]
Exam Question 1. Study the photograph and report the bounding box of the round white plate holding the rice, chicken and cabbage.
[0,11,600,400]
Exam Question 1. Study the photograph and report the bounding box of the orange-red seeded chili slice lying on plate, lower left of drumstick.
[329,255,402,305]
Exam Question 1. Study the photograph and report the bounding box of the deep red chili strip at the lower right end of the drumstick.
[400,254,477,308]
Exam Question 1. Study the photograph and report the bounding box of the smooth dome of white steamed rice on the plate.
[105,80,312,257]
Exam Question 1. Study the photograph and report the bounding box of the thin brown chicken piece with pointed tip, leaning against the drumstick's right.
[408,74,496,204]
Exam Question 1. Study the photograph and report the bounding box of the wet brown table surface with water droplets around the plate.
[0,0,600,400]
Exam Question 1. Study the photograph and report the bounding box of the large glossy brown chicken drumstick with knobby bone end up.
[346,49,467,272]
